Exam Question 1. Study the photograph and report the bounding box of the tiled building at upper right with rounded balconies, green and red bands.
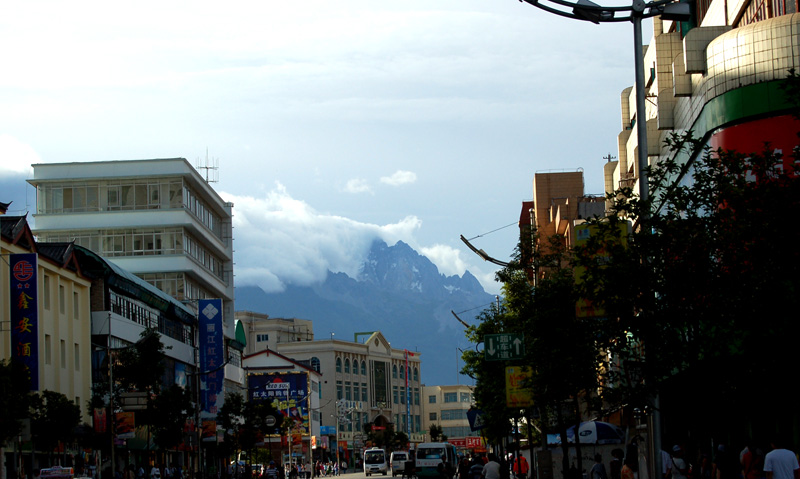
[605,0,800,197]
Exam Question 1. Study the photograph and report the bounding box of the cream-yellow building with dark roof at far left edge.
[0,214,92,423]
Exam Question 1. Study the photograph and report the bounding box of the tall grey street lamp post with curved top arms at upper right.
[520,0,691,471]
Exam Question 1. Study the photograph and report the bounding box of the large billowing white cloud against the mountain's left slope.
[221,183,428,292]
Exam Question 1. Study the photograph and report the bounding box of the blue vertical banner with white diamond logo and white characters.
[198,299,225,418]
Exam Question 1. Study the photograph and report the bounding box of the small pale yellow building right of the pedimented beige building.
[422,384,480,449]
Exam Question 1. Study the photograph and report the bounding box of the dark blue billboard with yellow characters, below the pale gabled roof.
[247,373,309,436]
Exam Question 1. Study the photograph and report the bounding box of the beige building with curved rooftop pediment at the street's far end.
[236,311,425,459]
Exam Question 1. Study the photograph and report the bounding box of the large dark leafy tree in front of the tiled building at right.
[576,125,800,441]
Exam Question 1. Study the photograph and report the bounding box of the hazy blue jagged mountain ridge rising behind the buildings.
[236,241,494,384]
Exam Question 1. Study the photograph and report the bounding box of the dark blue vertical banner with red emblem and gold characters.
[9,253,39,391]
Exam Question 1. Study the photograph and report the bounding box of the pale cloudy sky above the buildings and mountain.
[0,0,649,300]
